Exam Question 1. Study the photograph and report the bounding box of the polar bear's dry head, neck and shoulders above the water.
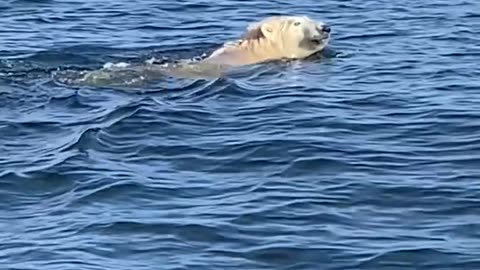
[201,16,331,66]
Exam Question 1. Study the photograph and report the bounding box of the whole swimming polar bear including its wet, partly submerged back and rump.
[59,16,330,85]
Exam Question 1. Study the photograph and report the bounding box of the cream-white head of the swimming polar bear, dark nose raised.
[241,16,330,59]
